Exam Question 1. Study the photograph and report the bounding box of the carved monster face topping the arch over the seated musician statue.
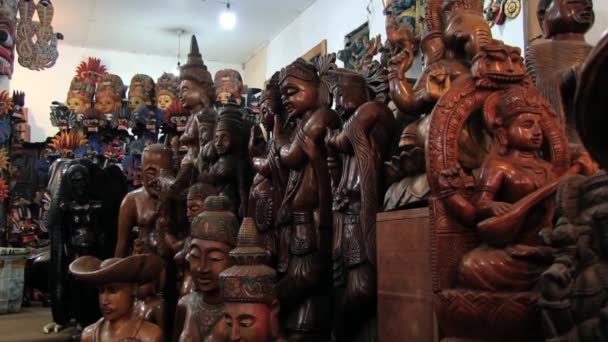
[471,44,528,89]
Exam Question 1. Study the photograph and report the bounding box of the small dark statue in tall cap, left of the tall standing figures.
[198,104,251,217]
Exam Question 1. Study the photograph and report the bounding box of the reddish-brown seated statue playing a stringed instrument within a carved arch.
[426,44,591,340]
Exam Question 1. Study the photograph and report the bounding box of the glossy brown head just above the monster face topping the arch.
[443,10,492,59]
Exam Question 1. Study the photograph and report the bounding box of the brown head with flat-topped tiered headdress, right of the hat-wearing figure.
[186,196,239,293]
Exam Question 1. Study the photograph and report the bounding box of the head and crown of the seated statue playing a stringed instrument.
[484,86,545,155]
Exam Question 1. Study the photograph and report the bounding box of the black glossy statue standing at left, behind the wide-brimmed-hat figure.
[45,159,126,332]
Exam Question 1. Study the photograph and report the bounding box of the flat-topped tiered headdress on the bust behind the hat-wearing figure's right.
[190,196,239,246]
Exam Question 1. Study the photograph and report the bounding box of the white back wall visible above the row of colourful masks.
[10,45,242,142]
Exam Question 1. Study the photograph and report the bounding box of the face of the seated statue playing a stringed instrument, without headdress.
[506,113,543,151]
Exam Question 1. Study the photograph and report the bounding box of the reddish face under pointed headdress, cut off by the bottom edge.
[224,303,277,342]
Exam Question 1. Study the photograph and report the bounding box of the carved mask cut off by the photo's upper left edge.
[0,1,18,79]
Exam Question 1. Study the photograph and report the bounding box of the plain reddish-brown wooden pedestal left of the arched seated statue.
[377,208,437,342]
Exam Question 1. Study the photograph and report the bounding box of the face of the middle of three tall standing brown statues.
[281,76,318,116]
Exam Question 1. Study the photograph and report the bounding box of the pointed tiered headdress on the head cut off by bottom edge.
[220,217,276,305]
